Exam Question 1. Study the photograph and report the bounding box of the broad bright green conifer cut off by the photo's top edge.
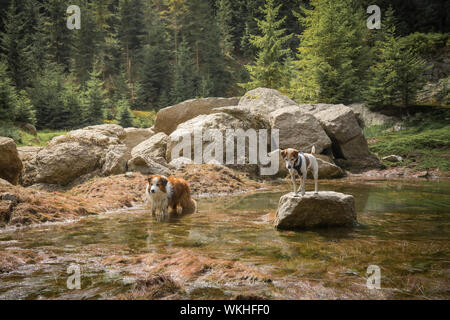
[290,0,371,103]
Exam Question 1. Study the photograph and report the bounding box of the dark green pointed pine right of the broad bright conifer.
[365,9,425,107]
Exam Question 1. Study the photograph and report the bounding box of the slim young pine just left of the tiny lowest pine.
[84,69,105,124]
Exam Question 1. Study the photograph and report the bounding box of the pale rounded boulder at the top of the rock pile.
[238,88,297,118]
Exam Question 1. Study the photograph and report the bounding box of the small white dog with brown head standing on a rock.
[281,146,319,196]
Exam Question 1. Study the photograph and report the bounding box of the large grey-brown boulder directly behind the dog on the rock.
[270,105,331,153]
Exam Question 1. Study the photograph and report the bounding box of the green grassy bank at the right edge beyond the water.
[364,112,450,172]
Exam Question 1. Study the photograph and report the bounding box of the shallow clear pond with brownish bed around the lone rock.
[0,180,450,299]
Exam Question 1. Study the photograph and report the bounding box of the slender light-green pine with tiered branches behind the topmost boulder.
[242,0,292,90]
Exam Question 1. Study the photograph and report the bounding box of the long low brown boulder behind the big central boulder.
[154,98,239,135]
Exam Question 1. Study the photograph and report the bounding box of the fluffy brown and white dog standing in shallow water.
[145,175,197,215]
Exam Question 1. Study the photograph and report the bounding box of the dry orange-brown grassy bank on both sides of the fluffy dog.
[0,165,265,227]
